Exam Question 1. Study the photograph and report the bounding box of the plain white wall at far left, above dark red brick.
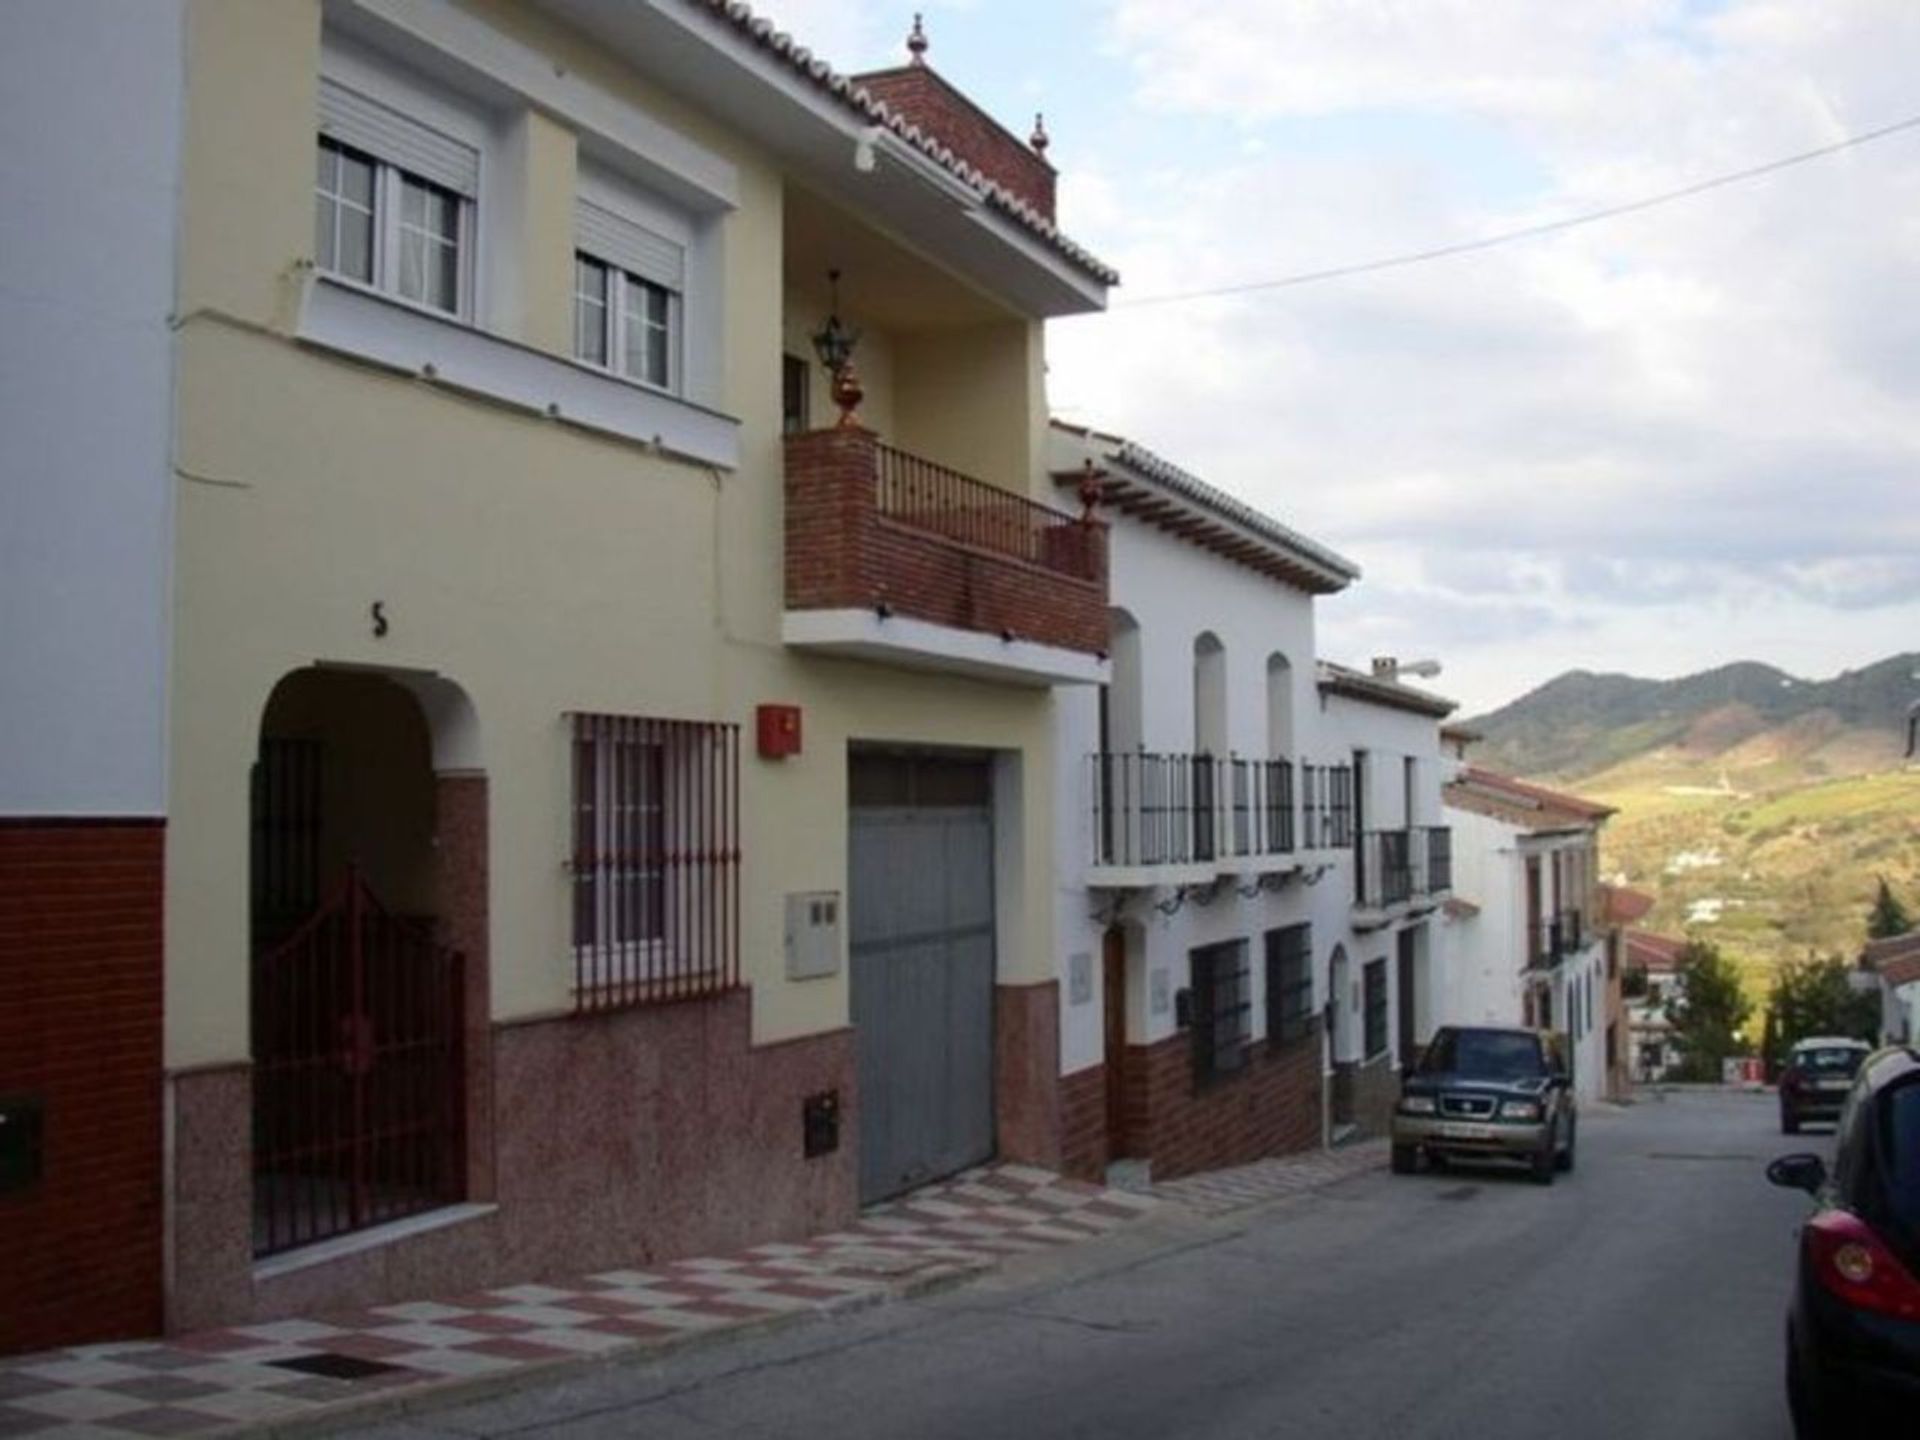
[0,0,184,816]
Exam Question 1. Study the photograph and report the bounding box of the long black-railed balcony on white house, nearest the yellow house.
[1087,751,1298,889]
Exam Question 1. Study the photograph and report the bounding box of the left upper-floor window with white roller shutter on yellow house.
[313,79,480,317]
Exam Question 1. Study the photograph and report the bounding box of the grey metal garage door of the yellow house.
[847,755,993,1204]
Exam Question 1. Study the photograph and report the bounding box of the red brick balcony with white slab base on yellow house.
[781,426,1108,685]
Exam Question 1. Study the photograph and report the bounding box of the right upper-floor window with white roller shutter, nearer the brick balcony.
[574,173,691,396]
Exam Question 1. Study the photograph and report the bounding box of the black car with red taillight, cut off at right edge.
[1766,1046,1920,1440]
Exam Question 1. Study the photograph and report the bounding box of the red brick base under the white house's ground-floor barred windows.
[1125,1033,1321,1181]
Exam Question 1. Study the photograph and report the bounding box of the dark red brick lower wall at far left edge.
[0,820,165,1354]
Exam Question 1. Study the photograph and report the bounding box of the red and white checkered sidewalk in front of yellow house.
[0,1165,1158,1438]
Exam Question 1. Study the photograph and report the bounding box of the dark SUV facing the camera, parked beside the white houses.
[1392,1025,1576,1185]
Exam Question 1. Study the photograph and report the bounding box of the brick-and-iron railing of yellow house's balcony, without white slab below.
[787,426,1108,655]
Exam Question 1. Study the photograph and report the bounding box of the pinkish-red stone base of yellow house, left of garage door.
[169,989,860,1331]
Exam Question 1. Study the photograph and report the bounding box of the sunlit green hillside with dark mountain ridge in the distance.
[1467,655,1920,993]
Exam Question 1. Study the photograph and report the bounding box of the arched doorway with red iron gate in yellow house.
[250,666,486,1256]
